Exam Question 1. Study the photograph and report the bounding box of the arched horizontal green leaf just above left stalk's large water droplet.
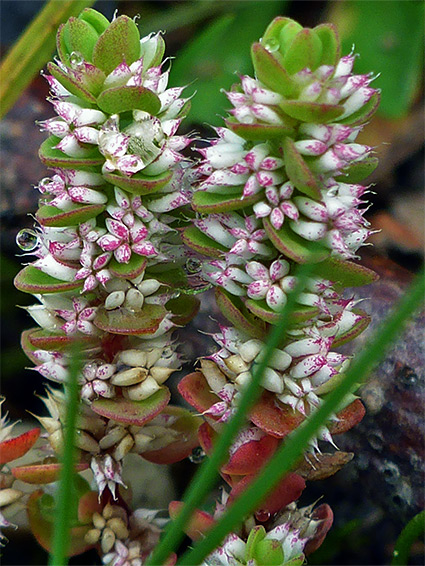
[97,86,161,115]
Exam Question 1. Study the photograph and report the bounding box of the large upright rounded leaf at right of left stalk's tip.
[93,16,140,74]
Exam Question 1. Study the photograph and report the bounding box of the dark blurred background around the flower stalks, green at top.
[0,0,425,565]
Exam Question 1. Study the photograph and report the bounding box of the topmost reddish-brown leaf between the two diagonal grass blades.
[249,391,304,438]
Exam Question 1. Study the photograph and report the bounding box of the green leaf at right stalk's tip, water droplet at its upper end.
[251,43,297,97]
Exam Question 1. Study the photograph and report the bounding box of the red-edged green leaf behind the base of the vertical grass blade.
[27,489,94,556]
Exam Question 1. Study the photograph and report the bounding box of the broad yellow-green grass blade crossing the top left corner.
[0,0,94,118]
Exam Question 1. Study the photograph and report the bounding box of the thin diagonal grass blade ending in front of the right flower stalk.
[147,265,313,566]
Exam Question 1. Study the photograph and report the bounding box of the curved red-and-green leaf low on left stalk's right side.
[141,406,203,464]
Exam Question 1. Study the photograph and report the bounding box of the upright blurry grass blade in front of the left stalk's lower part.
[49,347,81,566]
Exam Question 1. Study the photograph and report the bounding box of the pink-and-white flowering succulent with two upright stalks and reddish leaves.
[0,9,378,566]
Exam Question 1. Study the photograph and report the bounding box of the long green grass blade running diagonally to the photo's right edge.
[178,268,425,566]
